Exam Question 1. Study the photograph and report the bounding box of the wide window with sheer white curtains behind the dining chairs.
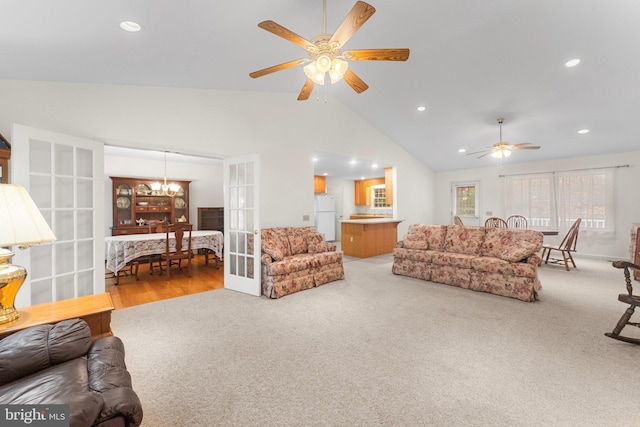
[505,169,614,231]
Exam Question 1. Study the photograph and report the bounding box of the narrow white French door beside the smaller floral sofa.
[223,154,261,296]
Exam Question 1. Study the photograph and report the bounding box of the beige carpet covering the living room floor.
[112,255,640,427]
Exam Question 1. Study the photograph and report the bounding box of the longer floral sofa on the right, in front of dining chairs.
[392,224,543,301]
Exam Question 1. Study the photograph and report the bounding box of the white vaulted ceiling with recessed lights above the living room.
[0,0,640,171]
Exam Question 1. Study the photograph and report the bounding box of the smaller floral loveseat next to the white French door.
[260,227,344,298]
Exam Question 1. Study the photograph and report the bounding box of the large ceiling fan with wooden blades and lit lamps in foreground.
[249,0,409,101]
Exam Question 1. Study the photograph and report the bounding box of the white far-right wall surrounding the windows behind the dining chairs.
[434,151,640,259]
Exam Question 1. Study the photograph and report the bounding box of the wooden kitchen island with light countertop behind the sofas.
[340,218,403,258]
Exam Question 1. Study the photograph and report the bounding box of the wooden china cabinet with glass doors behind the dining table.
[111,176,191,236]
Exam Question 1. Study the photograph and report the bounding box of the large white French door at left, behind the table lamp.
[11,125,105,307]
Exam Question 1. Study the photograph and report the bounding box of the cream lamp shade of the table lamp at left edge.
[0,184,56,247]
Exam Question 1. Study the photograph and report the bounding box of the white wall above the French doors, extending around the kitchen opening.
[0,80,434,237]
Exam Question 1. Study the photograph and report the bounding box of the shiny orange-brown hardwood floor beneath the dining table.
[106,255,224,310]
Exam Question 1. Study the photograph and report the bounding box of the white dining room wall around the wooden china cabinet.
[104,153,224,236]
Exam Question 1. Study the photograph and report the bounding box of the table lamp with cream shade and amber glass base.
[0,184,56,324]
